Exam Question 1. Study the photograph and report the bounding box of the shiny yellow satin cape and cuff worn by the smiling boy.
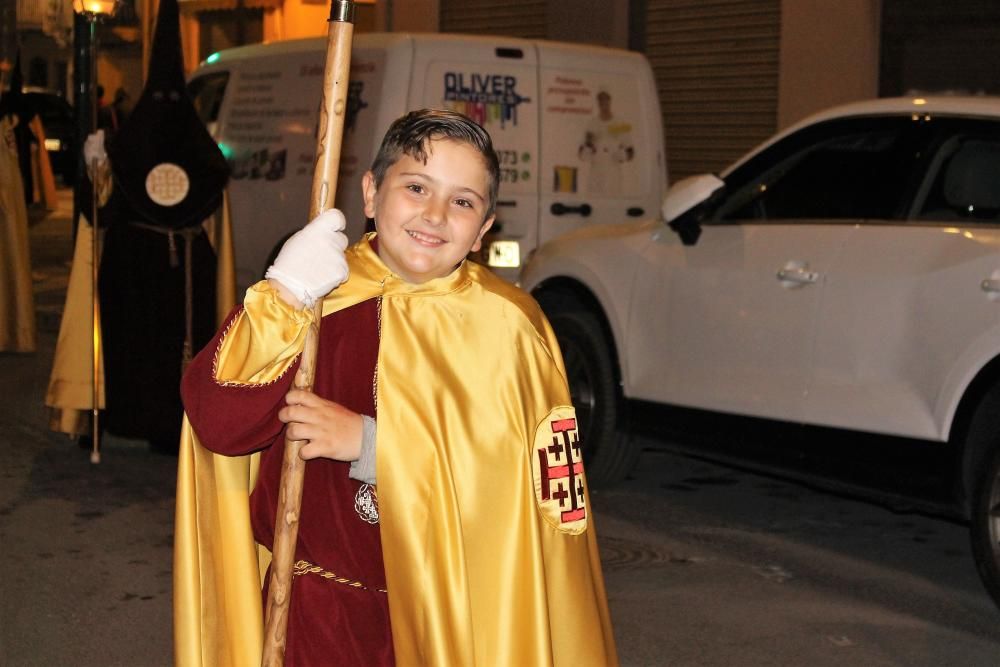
[174,237,617,667]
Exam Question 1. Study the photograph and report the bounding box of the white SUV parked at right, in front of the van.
[521,97,1000,604]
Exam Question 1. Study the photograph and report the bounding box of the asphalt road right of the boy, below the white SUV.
[594,450,1000,667]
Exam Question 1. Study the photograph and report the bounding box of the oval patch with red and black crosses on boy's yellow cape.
[531,406,587,535]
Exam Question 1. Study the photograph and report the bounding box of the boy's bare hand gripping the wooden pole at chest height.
[278,389,362,461]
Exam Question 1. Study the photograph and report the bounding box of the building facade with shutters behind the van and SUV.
[6,0,1000,181]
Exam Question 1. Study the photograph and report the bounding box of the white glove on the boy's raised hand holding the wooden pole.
[264,208,347,306]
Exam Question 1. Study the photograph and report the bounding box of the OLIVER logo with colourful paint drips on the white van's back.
[444,72,531,129]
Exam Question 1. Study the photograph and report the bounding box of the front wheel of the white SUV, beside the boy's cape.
[549,310,639,486]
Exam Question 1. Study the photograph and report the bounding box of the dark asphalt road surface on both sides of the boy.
[0,190,1000,667]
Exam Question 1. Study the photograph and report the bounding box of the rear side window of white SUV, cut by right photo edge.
[912,120,1000,224]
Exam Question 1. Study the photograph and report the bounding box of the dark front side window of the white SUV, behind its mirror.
[711,116,919,222]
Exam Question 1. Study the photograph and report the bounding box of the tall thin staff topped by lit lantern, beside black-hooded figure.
[73,0,117,463]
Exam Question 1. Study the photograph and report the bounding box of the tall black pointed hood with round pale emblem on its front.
[108,0,229,228]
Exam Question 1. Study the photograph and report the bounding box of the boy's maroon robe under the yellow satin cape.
[181,300,394,667]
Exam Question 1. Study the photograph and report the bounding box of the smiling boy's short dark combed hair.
[372,109,500,221]
